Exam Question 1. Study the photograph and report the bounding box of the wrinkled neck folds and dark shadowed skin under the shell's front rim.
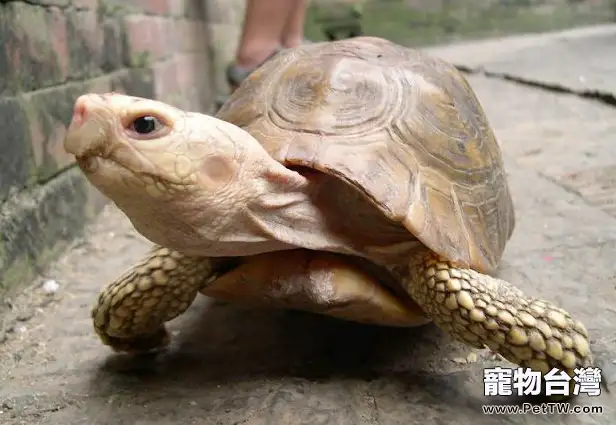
[251,169,422,266]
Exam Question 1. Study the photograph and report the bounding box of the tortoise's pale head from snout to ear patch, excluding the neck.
[64,93,258,202]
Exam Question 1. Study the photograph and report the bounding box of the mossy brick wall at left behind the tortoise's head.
[0,0,243,297]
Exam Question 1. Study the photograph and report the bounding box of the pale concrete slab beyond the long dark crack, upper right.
[427,25,616,97]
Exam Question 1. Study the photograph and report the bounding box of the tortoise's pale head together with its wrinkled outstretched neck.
[64,93,336,256]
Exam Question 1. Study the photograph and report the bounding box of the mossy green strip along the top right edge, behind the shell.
[306,0,616,45]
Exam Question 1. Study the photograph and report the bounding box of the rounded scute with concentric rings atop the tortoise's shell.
[268,56,401,137]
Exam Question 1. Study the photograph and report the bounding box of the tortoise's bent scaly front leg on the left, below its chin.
[92,246,219,352]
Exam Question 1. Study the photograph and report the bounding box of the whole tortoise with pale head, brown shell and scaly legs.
[65,36,593,375]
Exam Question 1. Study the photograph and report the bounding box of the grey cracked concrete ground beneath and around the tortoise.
[0,26,616,425]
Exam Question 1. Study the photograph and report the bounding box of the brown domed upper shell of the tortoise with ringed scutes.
[217,37,515,273]
